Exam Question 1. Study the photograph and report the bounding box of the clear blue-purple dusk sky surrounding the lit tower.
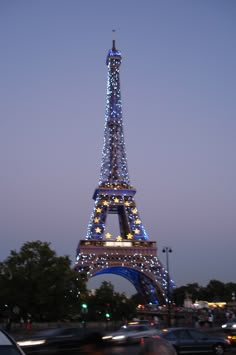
[0,0,236,294]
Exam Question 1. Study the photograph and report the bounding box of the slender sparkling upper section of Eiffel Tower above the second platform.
[99,30,130,188]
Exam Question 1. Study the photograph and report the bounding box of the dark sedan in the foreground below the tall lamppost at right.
[159,327,231,355]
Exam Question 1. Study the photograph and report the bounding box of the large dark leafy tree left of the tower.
[0,241,86,320]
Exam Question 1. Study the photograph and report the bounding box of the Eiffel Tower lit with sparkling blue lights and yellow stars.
[75,40,174,304]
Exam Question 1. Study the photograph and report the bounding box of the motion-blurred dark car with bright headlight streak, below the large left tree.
[17,327,102,355]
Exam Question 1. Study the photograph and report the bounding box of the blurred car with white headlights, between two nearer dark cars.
[102,324,158,344]
